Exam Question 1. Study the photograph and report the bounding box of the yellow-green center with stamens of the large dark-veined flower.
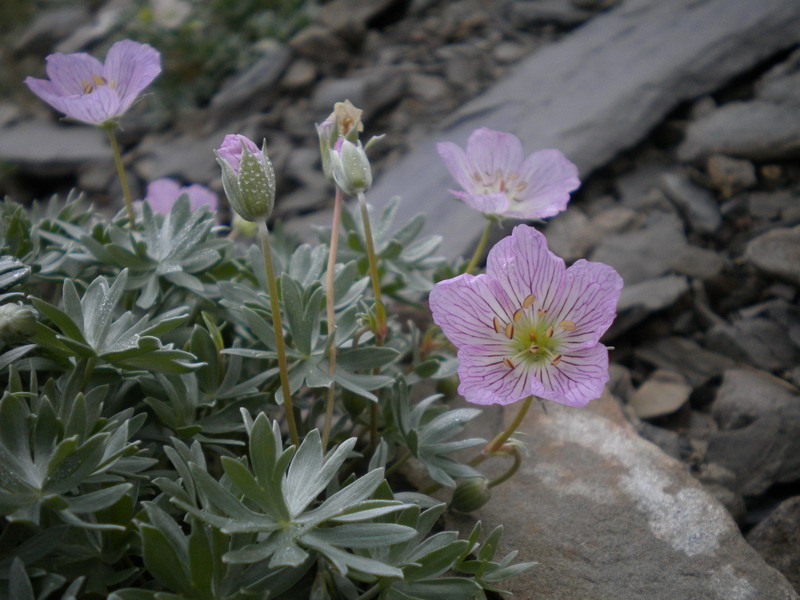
[492,295,575,369]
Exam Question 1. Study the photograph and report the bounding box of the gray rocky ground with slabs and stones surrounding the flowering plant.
[0,0,800,600]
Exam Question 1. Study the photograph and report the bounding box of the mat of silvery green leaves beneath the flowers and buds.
[0,186,530,600]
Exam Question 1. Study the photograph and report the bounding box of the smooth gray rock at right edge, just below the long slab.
[678,100,800,161]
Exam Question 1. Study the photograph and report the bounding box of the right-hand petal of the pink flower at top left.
[103,40,161,114]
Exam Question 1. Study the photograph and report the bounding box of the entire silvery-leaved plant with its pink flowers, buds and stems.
[0,41,621,600]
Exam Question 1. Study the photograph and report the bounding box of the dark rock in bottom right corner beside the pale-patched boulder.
[747,496,800,590]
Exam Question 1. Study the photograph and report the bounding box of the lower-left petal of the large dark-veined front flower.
[458,345,538,404]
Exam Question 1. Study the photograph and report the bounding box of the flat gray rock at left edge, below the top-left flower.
[0,121,111,174]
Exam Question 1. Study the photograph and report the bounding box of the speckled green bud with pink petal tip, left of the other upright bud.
[216,134,275,221]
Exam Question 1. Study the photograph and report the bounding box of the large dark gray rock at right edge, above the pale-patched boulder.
[707,369,800,496]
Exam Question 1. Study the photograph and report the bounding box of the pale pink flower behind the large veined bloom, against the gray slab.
[436,127,581,219]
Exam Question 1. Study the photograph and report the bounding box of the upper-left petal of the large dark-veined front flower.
[429,274,514,352]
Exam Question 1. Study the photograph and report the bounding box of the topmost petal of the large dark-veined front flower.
[486,225,566,309]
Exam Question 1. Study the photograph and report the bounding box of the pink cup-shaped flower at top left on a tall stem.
[25,40,161,125]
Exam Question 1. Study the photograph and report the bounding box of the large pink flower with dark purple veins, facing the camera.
[430,225,622,406]
